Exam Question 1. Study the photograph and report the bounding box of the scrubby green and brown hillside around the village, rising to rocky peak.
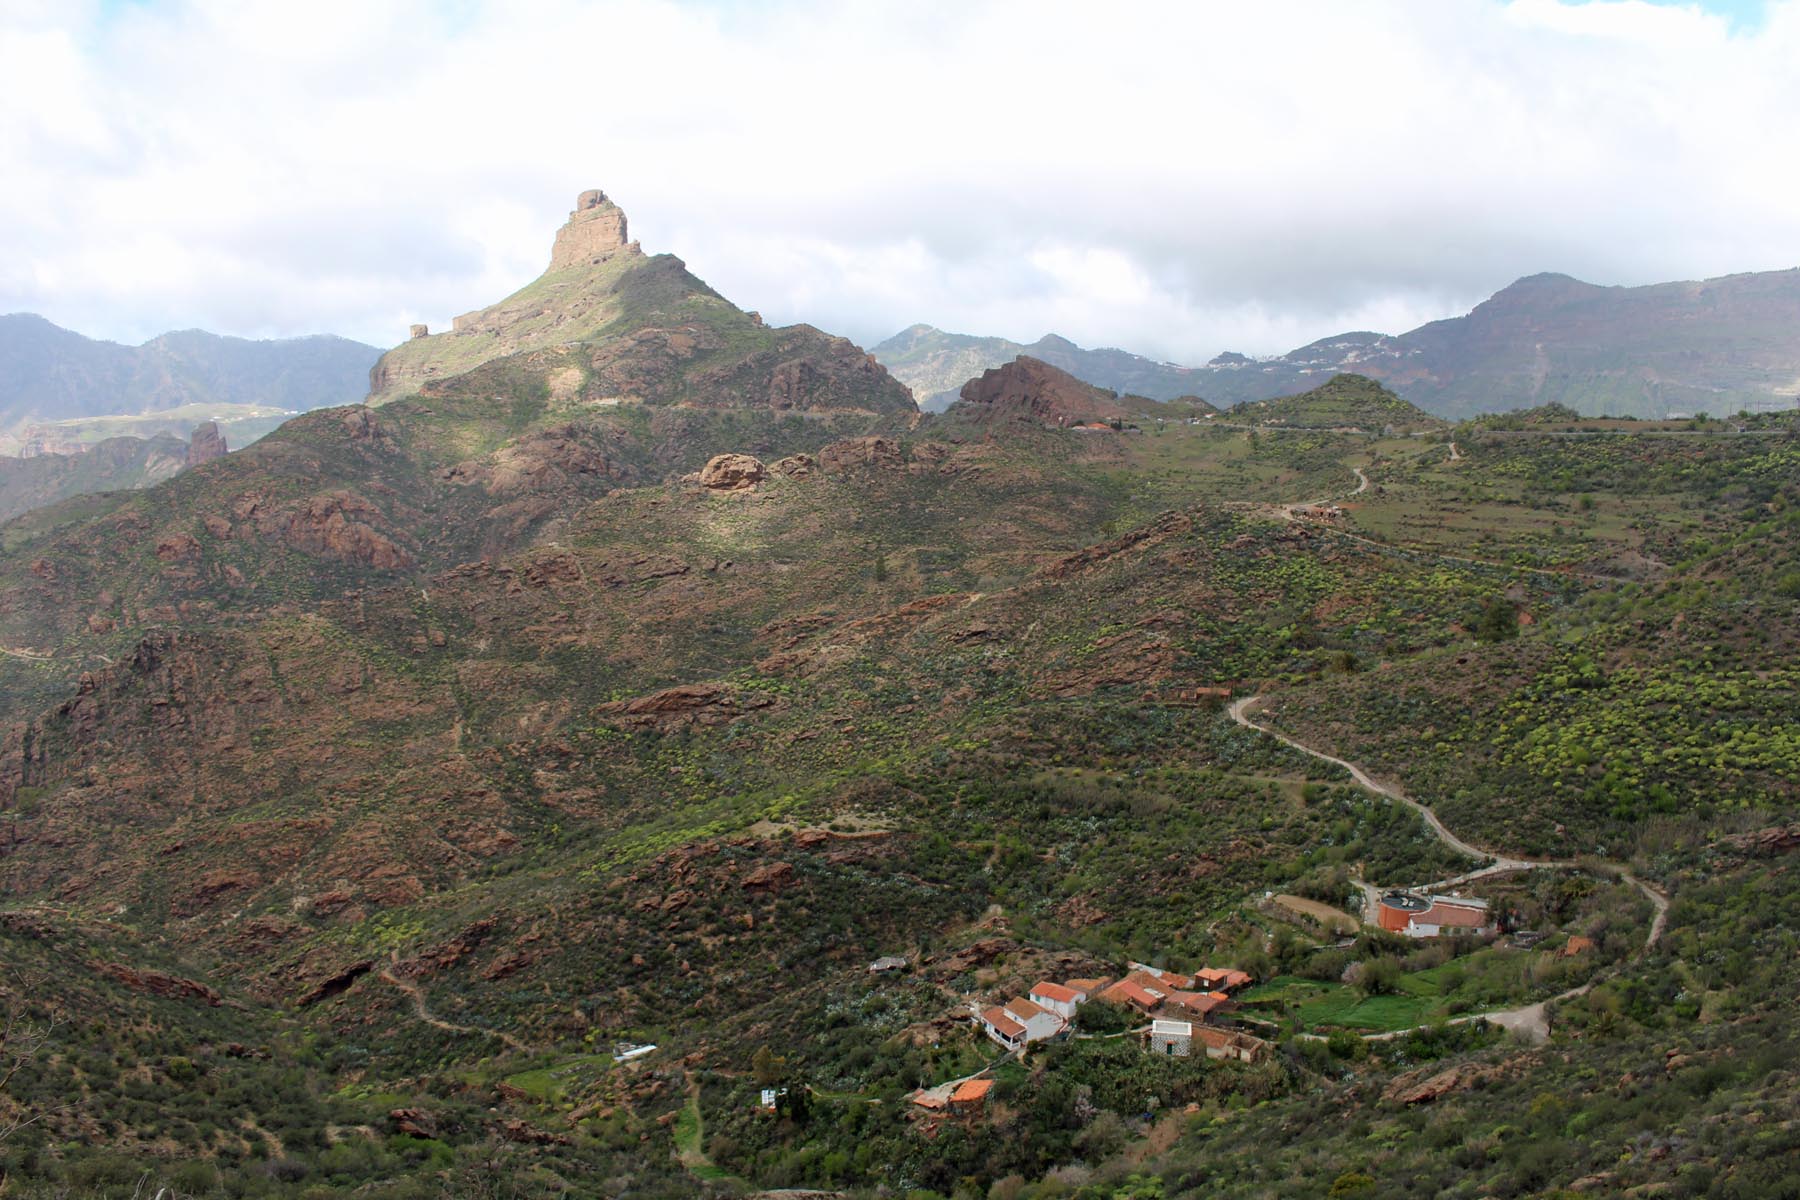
[0,198,1800,1200]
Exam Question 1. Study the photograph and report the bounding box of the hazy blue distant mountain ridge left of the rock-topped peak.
[0,313,382,430]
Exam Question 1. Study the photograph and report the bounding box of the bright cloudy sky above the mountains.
[0,0,1800,362]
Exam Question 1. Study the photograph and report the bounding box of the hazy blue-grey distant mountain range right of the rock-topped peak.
[875,270,1800,419]
